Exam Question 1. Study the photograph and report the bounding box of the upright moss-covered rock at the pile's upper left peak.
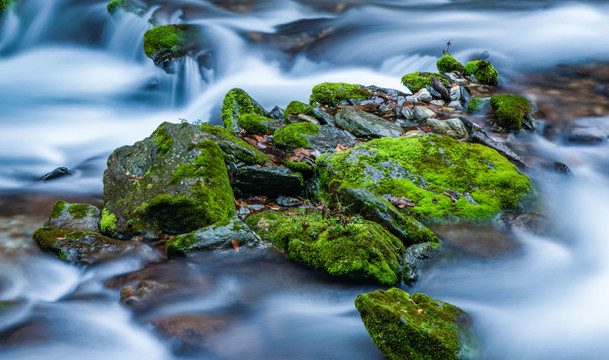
[222,88,269,132]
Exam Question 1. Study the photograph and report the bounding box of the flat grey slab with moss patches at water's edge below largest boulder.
[166,218,259,257]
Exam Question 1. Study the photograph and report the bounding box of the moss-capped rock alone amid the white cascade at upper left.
[144,24,204,73]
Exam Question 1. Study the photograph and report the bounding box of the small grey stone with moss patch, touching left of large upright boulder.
[44,201,101,232]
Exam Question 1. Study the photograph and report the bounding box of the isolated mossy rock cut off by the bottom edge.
[355,288,472,360]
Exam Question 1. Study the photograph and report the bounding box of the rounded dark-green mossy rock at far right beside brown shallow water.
[490,94,534,131]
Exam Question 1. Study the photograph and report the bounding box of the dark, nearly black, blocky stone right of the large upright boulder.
[234,166,303,195]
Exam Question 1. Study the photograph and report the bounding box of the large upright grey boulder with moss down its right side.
[101,123,235,239]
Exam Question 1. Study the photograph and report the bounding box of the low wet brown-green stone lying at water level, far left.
[33,227,158,264]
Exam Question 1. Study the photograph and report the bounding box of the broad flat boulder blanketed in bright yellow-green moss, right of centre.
[316,134,532,223]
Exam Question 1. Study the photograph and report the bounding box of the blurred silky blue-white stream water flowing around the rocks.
[0,0,609,360]
